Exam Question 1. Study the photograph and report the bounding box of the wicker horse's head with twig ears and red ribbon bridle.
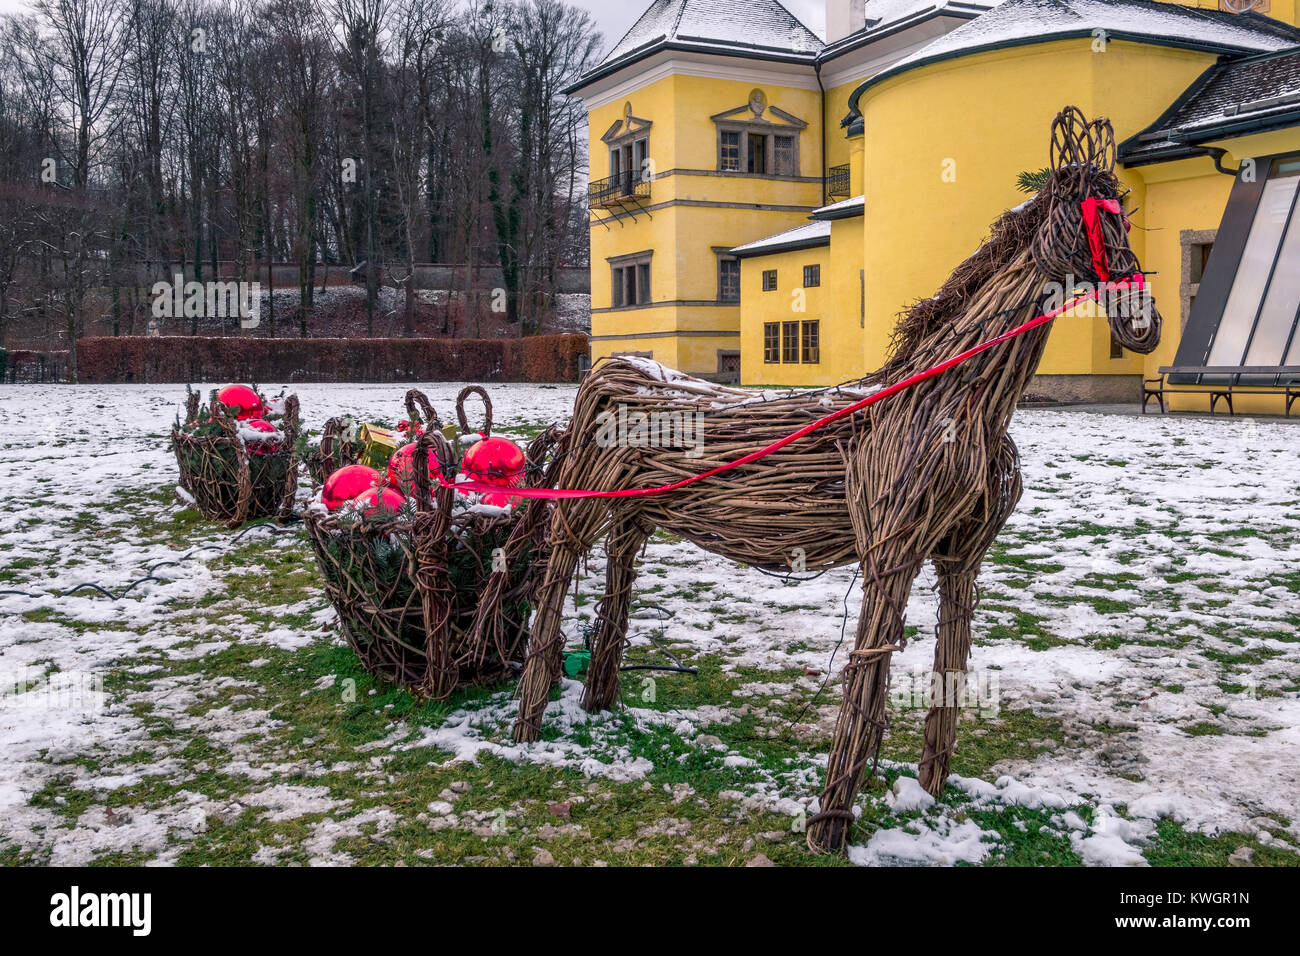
[1032,107,1161,354]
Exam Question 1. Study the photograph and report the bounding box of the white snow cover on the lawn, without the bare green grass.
[0,384,1300,864]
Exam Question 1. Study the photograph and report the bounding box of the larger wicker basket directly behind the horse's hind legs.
[304,386,563,700]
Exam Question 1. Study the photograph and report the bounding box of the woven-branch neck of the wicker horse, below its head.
[897,257,1050,419]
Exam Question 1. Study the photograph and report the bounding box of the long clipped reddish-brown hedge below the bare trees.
[77,334,588,382]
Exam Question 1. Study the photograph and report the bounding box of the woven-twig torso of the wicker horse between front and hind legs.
[584,356,866,571]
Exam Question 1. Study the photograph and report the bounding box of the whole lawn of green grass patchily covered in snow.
[0,384,1300,864]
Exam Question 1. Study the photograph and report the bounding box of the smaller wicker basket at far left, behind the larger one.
[172,392,298,528]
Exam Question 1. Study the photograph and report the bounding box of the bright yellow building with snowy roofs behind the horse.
[572,0,1300,411]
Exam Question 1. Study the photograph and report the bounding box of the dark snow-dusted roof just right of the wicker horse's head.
[1119,47,1300,165]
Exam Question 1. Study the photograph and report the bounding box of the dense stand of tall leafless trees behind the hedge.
[0,0,599,351]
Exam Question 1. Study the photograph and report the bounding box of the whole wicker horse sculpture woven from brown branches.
[515,107,1160,851]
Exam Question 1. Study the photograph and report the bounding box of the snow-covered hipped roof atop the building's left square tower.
[579,0,824,86]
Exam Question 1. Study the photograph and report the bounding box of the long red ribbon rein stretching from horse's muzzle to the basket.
[438,272,1144,498]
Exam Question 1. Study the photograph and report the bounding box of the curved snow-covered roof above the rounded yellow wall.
[849,0,1300,109]
